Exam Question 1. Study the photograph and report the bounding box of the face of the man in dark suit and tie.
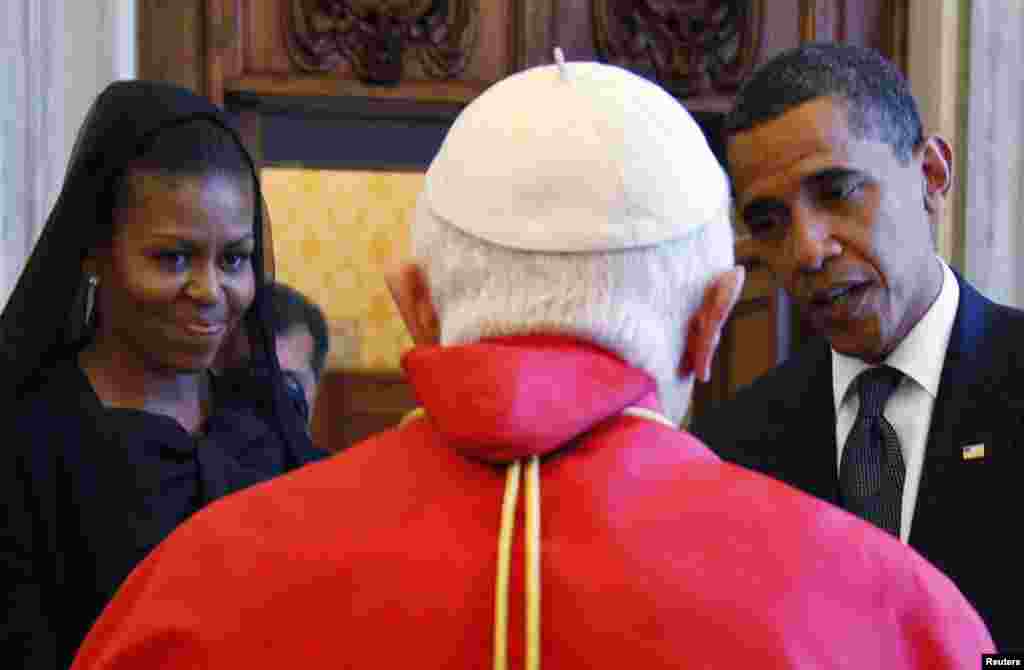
[728,97,942,362]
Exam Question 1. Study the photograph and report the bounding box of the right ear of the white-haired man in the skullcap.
[679,265,746,382]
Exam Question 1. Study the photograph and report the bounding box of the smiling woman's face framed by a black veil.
[90,171,256,373]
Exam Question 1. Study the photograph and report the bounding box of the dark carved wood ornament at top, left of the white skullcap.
[287,0,480,84]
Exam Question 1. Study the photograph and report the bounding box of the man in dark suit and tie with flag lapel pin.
[692,44,1024,648]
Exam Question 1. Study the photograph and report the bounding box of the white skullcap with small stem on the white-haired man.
[423,51,729,252]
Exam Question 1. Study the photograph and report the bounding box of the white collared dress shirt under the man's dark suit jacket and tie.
[831,256,959,543]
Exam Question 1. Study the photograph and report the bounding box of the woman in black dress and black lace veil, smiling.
[0,82,323,669]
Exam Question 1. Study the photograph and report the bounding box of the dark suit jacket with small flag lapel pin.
[691,275,1024,650]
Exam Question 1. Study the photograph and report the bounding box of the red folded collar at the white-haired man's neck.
[401,336,655,463]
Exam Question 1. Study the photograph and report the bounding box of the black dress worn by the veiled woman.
[0,360,325,670]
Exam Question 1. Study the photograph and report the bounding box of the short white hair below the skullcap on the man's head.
[412,196,734,424]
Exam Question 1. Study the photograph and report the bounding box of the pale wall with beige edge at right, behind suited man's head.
[908,0,1024,306]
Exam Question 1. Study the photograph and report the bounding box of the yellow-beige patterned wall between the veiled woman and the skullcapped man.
[262,168,423,370]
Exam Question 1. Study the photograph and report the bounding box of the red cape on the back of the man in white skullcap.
[74,342,992,670]
